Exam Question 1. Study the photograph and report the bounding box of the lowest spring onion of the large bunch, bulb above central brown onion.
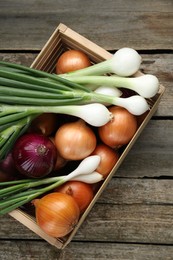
[0,103,111,159]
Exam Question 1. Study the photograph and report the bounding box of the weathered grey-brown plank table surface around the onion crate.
[0,0,173,260]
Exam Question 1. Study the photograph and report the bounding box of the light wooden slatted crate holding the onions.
[9,24,164,249]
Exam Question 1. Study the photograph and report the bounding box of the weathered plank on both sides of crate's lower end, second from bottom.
[0,203,173,245]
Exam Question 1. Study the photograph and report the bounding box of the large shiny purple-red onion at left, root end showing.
[13,133,57,178]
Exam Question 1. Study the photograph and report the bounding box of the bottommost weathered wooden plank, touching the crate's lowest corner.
[0,240,173,260]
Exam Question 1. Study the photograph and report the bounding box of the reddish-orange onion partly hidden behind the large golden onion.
[55,181,94,213]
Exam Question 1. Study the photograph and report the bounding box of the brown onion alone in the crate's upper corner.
[56,50,91,74]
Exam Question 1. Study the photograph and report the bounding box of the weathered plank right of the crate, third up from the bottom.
[98,178,173,205]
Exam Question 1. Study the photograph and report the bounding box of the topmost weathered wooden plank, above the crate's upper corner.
[0,0,173,50]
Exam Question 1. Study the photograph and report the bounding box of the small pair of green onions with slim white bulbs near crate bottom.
[0,155,103,215]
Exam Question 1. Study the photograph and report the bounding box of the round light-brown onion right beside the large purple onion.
[55,120,97,160]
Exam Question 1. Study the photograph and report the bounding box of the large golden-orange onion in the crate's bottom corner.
[33,192,80,237]
